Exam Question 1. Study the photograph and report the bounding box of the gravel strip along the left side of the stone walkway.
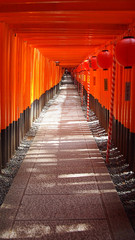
[0,94,57,205]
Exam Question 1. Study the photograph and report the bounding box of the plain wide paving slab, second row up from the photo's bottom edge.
[16,194,105,220]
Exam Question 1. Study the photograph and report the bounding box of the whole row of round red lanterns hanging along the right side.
[74,36,135,72]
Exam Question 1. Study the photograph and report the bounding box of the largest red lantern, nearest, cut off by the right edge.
[116,36,135,68]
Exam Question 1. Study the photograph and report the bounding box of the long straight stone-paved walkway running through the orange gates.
[0,84,135,240]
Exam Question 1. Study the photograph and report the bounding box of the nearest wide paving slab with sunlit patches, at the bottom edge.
[11,220,112,240]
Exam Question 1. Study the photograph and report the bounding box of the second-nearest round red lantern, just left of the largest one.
[97,50,113,70]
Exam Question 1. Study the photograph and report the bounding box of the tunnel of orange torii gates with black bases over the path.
[0,0,135,171]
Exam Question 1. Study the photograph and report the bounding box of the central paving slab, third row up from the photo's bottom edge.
[25,174,98,195]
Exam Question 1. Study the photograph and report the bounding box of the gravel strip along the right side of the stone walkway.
[82,95,135,231]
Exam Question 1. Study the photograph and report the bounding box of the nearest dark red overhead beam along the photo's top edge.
[0,0,135,13]
